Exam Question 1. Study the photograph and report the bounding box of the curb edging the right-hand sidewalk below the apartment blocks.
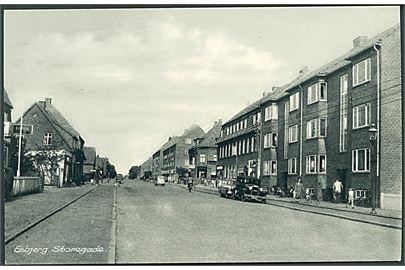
[179,186,402,229]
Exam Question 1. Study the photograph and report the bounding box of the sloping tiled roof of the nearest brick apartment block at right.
[287,24,400,90]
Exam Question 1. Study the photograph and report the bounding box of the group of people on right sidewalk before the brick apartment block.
[290,178,354,208]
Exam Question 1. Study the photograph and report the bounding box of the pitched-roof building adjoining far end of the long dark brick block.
[188,120,222,180]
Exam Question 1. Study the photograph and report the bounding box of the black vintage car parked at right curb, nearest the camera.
[233,175,268,203]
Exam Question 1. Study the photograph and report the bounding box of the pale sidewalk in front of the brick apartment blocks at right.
[180,182,402,229]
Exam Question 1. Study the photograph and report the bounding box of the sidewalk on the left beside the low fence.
[4,184,96,242]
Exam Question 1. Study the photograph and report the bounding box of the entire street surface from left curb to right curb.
[6,180,401,264]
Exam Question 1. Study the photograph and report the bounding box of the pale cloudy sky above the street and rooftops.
[4,6,399,173]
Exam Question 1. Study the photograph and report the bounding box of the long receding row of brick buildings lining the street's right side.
[142,25,403,209]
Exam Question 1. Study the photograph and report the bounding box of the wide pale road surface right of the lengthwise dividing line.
[116,181,401,263]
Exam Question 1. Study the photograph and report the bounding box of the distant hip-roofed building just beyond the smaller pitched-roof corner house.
[161,125,204,181]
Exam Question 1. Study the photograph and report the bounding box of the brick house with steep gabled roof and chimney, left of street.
[15,98,85,187]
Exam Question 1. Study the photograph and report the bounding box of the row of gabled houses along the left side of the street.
[3,93,113,187]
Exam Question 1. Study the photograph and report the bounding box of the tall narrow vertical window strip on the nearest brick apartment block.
[339,74,349,152]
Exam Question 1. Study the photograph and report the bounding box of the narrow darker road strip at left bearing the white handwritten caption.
[6,184,114,264]
